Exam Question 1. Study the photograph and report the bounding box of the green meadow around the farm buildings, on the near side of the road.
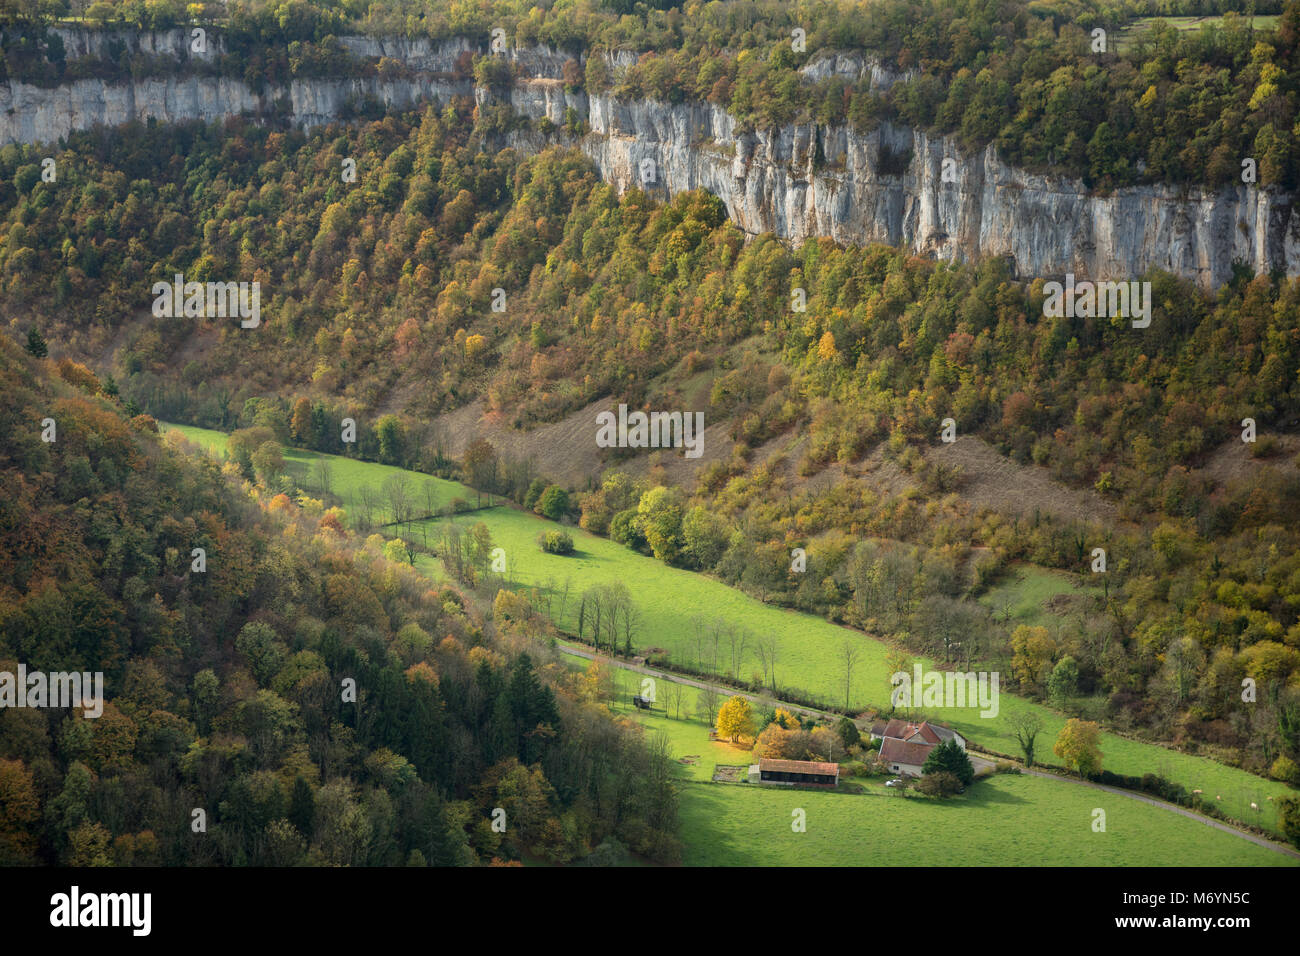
[566,656,1296,866]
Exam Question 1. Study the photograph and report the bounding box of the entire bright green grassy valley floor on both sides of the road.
[166,425,1295,866]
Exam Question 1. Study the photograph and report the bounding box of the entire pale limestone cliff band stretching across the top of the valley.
[0,31,1300,287]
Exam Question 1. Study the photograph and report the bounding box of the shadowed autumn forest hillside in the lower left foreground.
[0,338,679,866]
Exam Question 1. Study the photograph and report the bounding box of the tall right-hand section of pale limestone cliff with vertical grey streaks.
[581,96,1300,287]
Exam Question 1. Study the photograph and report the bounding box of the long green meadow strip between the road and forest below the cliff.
[165,425,1291,834]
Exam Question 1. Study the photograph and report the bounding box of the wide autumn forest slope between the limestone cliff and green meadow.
[10,93,1300,777]
